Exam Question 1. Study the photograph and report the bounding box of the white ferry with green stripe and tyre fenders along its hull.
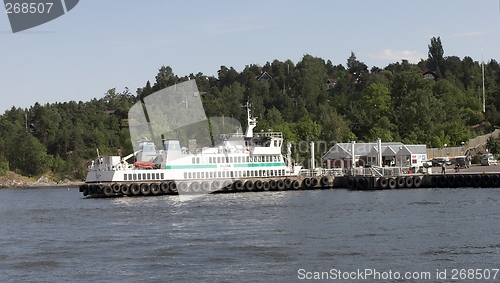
[80,95,302,197]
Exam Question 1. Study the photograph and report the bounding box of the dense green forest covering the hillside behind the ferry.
[0,37,500,180]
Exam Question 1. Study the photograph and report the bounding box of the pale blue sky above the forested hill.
[0,0,500,113]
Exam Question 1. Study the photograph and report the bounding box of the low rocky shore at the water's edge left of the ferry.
[0,172,84,189]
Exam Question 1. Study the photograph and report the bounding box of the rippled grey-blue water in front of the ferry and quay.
[0,187,500,282]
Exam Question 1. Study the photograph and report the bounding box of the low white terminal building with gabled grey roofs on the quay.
[322,142,427,169]
